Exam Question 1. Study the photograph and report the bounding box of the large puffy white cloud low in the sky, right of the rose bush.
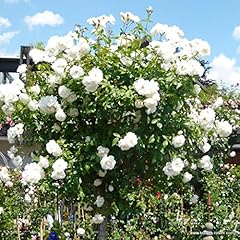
[208,54,240,87]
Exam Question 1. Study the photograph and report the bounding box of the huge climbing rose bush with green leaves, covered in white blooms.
[0,8,239,239]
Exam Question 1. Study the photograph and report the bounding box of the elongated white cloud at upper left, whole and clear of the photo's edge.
[24,11,64,29]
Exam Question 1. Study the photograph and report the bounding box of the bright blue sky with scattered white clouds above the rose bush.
[0,0,240,85]
